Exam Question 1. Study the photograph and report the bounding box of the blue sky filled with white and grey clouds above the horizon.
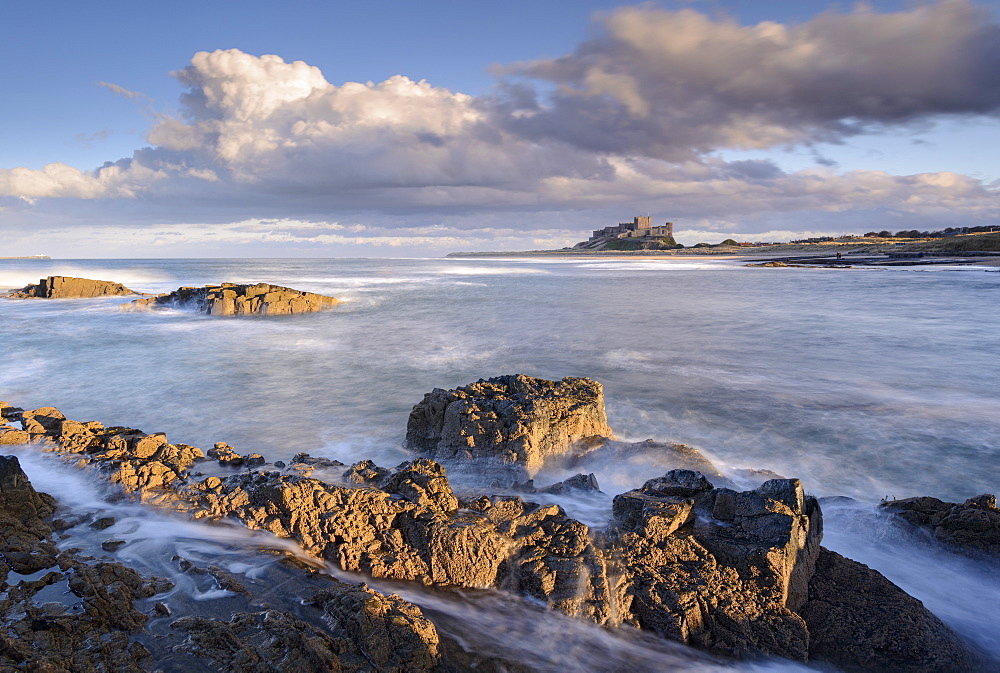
[0,0,1000,258]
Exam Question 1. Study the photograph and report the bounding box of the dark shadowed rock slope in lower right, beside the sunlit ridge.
[801,549,988,673]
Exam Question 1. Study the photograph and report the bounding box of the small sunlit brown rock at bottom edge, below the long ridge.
[309,585,440,673]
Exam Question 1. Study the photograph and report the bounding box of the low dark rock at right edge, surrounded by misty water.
[881,493,1000,559]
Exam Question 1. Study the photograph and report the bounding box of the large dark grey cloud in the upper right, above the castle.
[494,0,1000,159]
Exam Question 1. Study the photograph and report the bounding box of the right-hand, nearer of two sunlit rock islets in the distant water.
[127,283,337,316]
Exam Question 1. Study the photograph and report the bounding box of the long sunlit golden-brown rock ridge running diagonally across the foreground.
[7,394,992,670]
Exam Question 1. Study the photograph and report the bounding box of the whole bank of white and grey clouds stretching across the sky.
[0,0,1000,246]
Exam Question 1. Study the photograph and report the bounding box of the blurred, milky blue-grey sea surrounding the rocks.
[0,257,1000,671]
